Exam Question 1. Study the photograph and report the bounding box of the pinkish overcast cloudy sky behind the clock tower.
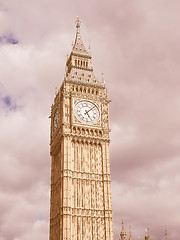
[0,0,180,240]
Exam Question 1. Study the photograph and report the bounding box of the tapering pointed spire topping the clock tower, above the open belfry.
[72,17,90,55]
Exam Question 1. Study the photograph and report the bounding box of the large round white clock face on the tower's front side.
[74,101,99,124]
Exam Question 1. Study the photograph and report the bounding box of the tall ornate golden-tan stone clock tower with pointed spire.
[50,18,113,240]
